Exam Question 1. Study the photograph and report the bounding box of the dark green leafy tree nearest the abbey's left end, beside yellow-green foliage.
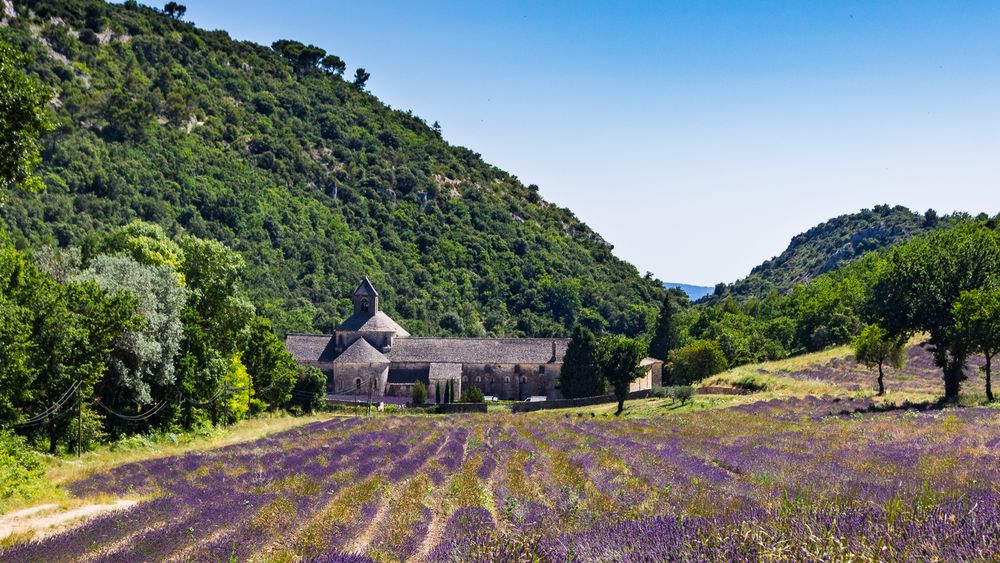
[242,317,297,411]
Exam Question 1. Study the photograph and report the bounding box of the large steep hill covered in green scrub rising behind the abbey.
[0,0,662,336]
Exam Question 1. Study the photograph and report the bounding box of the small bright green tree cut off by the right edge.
[953,289,1000,402]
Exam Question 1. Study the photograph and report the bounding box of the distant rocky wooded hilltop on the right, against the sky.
[730,205,968,297]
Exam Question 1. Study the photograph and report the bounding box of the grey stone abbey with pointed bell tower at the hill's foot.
[285,277,663,402]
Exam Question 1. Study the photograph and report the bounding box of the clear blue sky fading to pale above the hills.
[180,0,1000,284]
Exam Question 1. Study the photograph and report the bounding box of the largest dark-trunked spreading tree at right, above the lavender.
[866,222,1000,401]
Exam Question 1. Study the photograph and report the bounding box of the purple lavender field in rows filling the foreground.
[0,398,1000,561]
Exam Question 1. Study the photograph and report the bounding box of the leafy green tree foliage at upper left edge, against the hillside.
[0,41,52,197]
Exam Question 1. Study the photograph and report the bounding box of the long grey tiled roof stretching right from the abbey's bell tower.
[389,337,569,364]
